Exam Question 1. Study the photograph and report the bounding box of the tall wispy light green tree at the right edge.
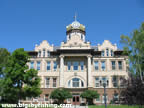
[121,23,144,81]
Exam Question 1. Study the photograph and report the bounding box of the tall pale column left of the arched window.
[59,55,64,87]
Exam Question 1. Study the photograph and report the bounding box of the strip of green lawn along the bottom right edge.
[88,105,144,108]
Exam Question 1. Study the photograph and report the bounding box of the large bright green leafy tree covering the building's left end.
[1,48,41,103]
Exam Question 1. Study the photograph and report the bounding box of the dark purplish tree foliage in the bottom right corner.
[121,75,144,106]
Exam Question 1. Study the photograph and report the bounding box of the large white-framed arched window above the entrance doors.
[68,78,84,88]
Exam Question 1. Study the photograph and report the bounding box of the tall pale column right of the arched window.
[87,55,93,87]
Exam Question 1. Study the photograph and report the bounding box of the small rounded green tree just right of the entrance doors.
[80,90,99,105]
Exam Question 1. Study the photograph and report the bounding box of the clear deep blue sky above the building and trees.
[0,0,144,52]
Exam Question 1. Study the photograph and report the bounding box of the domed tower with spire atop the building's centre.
[66,17,85,42]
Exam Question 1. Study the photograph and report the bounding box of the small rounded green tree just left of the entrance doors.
[50,89,72,104]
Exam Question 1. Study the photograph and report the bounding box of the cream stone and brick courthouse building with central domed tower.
[26,20,128,104]
